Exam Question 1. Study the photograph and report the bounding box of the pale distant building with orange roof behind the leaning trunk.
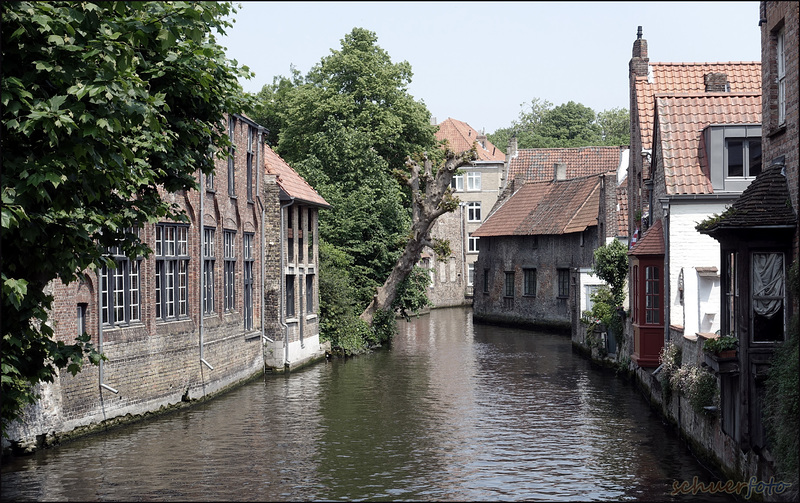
[420,118,505,307]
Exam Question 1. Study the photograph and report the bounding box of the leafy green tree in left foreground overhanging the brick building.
[0,2,250,435]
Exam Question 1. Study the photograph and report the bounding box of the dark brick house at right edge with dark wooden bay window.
[697,2,800,480]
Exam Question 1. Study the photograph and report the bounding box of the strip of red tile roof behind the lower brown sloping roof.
[508,147,627,182]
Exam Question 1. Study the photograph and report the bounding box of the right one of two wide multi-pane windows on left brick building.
[155,224,189,320]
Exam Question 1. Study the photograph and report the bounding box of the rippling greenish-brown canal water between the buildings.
[1,308,732,501]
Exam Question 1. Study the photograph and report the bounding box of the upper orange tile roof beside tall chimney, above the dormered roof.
[634,61,761,162]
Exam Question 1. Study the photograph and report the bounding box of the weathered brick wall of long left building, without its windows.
[3,117,278,448]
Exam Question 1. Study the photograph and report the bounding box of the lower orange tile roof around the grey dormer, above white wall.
[655,92,761,195]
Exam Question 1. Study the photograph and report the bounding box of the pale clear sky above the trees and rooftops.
[219,1,761,133]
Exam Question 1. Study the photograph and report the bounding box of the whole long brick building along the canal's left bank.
[3,115,327,449]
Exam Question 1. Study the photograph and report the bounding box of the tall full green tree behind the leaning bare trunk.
[257,28,442,336]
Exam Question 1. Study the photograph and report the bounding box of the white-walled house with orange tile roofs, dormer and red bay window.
[627,27,762,367]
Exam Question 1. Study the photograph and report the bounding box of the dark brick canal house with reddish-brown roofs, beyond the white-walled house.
[473,145,624,332]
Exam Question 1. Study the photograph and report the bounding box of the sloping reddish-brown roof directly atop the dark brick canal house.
[472,176,600,237]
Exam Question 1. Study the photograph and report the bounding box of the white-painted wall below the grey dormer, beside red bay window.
[669,201,726,335]
